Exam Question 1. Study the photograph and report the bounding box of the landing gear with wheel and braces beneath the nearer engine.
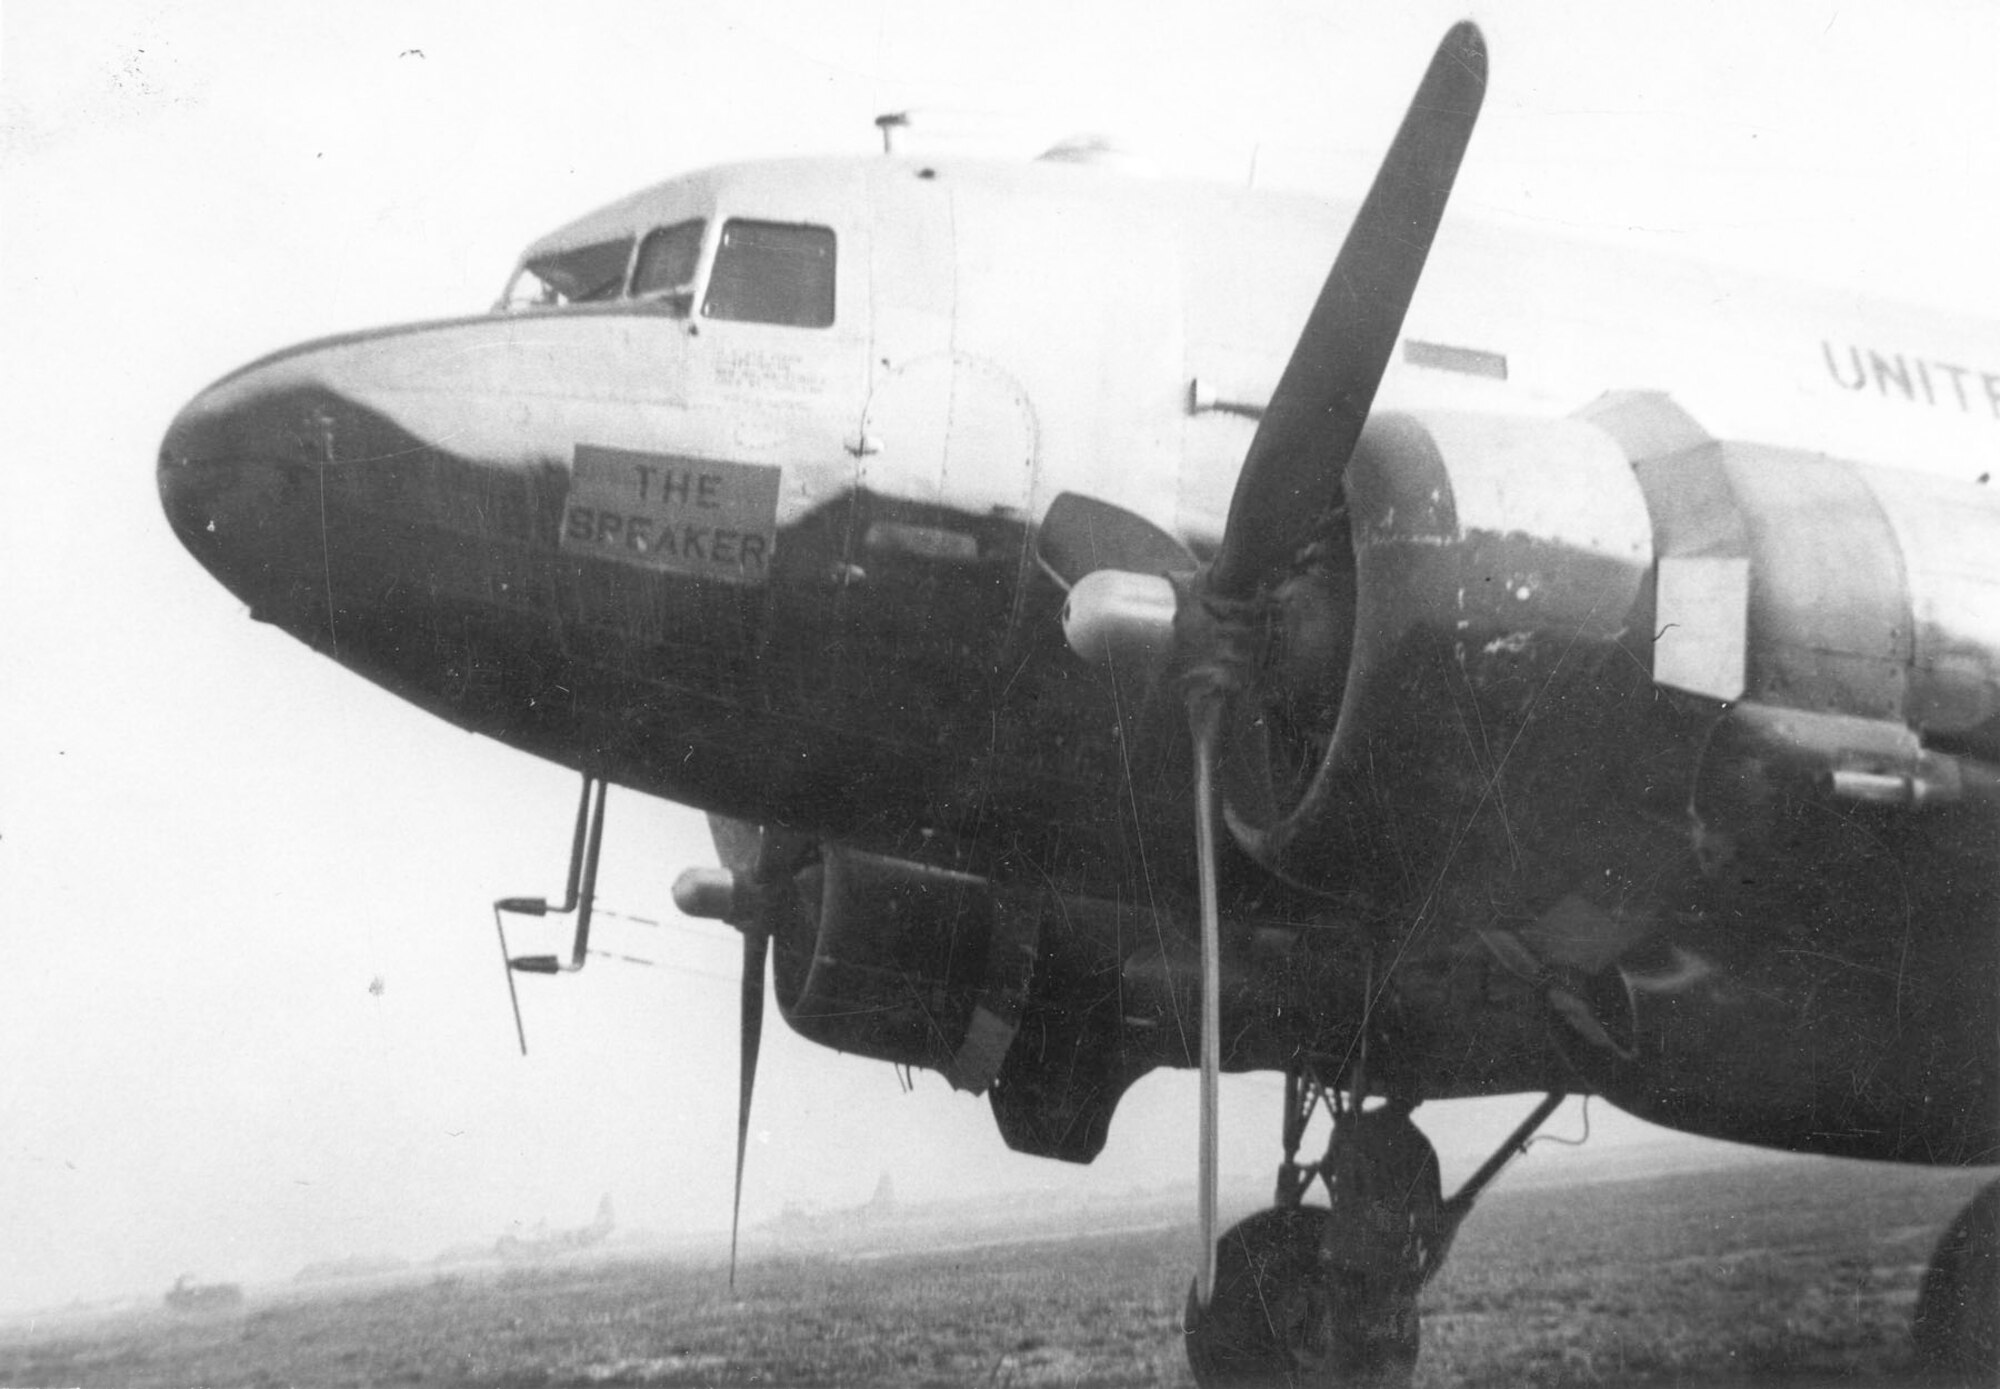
[1184,1073,1562,1389]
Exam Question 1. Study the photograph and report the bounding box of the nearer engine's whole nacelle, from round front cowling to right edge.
[1230,392,2000,881]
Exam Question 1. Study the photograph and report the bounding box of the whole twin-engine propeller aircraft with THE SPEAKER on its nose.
[158,24,2000,1383]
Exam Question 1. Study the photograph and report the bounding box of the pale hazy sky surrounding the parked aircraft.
[0,0,2000,1309]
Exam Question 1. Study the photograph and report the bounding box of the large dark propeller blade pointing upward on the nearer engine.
[1208,20,1486,600]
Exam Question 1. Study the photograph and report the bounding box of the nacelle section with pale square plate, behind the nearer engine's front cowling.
[1616,396,2000,761]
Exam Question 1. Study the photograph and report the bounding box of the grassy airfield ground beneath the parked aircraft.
[0,1161,1982,1389]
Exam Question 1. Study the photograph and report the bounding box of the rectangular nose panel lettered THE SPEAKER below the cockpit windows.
[562,444,782,584]
